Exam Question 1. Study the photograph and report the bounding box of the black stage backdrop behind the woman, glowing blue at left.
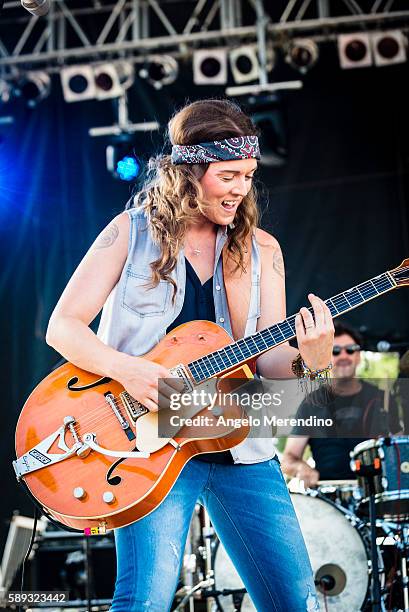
[0,47,409,552]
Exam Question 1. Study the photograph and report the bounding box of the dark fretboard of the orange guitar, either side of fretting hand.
[188,272,397,382]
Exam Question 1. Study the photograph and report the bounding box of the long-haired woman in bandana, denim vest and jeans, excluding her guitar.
[47,100,333,612]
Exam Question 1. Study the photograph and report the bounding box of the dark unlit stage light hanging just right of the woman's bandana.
[248,94,287,167]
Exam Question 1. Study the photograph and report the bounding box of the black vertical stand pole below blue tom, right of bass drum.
[351,457,382,612]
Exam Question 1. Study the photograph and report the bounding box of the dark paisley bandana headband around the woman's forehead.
[172,136,260,165]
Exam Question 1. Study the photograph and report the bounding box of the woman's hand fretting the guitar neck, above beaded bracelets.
[295,293,334,370]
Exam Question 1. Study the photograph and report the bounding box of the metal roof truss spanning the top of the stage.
[0,0,409,75]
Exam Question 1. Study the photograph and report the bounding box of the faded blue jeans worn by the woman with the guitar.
[111,458,319,612]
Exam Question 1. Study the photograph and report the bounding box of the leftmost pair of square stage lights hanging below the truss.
[61,61,135,102]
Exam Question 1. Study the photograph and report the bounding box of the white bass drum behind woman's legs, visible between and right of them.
[213,492,384,612]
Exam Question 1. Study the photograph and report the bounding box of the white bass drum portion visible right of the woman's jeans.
[291,492,384,612]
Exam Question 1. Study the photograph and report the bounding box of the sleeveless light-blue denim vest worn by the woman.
[97,208,275,463]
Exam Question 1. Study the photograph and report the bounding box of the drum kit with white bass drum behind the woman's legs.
[174,436,409,612]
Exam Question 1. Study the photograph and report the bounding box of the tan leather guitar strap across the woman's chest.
[222,235,252,340]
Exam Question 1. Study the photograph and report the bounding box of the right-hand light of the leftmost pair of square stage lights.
[93,62,135,100]
